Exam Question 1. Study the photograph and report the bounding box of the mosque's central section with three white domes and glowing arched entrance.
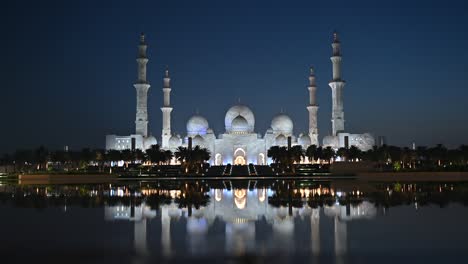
[179,105,296,165]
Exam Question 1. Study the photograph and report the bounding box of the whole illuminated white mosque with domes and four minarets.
[106,32,375,165]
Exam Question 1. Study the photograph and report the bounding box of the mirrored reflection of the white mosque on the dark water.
[105,186,376,256]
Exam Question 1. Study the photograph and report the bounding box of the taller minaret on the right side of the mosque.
[328,32,345,136]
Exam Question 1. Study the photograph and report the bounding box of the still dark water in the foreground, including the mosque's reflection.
[0,180,468,263]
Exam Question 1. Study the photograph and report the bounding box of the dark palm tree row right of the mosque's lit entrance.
[267,144,468,172]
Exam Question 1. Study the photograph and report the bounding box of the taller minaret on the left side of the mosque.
[133,33,150,137]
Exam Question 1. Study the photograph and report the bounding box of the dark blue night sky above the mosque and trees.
[0,0,468,152]
